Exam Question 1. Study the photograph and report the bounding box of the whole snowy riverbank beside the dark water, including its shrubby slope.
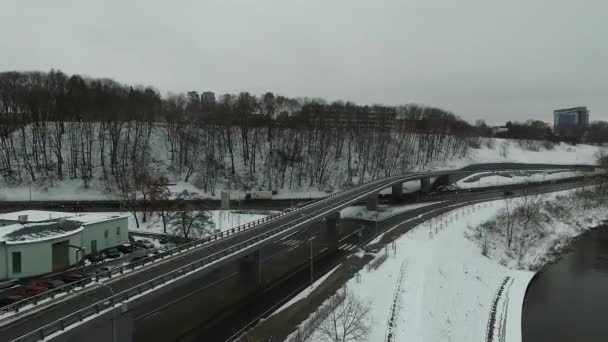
[288,190,606,342]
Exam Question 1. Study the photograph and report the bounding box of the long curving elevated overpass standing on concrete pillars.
[0,164,600,341]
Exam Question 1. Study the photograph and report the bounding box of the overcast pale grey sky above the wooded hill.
[0,0,608,123]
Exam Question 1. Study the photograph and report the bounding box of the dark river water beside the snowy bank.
[522,227,608,342]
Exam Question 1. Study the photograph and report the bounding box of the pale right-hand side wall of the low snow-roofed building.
[82,217,129,255]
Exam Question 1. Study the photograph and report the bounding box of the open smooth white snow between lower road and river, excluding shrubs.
[296,201,532,341]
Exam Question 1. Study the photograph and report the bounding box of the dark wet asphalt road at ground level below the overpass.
[134,178,600,342]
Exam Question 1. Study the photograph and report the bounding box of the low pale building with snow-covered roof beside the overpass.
[0,210,129,279]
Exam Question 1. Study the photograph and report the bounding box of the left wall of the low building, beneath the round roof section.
[0,232,82,279]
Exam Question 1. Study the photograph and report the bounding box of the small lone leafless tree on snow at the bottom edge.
[318,288,371,342]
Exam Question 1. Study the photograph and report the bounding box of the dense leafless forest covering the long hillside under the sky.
[0,70,604,199]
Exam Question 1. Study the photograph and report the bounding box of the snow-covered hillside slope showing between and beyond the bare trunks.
[0,125,600,200]
